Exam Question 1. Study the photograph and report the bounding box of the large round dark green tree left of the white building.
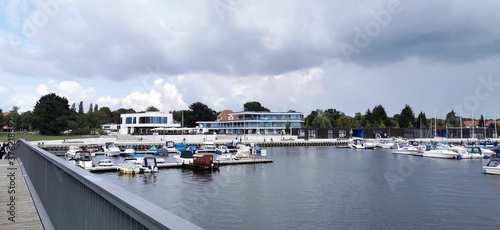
[33,93,71,135]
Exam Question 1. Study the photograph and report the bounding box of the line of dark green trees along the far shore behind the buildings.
[0,93,493,135]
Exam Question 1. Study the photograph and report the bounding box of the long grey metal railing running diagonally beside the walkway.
[15,140,200,229]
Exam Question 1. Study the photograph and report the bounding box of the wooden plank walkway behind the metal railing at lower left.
[0,159,44,229]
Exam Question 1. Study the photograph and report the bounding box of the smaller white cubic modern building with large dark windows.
[120,112,181,134]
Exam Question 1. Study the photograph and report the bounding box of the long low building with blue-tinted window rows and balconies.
[196,112,304,135]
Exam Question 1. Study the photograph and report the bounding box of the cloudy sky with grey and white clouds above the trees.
[0,0,500,118]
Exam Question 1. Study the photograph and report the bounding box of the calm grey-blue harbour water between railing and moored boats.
[97,147,500,229]
